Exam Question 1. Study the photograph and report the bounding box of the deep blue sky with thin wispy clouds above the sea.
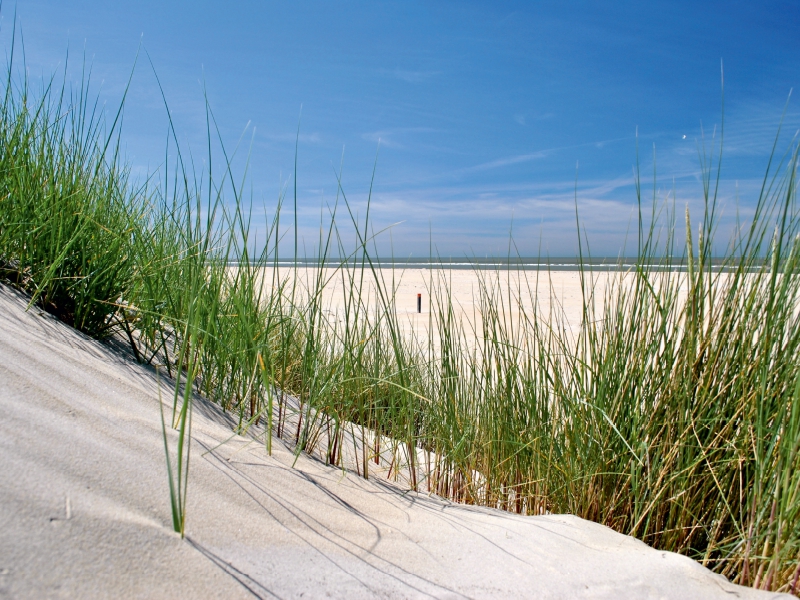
[6,0,800,257]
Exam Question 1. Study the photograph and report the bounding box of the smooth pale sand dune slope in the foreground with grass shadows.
[0,286,788,598]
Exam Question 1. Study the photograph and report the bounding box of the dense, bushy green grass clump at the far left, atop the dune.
[0,52,136,337]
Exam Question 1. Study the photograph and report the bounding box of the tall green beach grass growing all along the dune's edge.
[0,44,800,592]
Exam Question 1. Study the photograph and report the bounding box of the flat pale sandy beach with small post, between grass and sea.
[261,266,629,345]
